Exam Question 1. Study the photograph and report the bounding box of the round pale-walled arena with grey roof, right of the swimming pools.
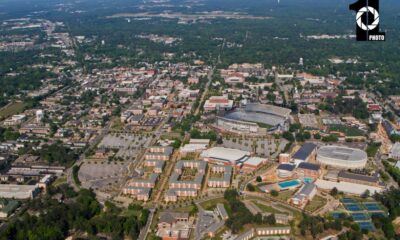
[317,145,368,169]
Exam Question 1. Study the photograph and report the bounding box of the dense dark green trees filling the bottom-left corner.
[0,185,148,240]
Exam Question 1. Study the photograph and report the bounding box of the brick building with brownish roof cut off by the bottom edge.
[157,212,191,240]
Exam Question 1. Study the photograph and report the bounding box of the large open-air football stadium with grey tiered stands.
[218,103,291,132]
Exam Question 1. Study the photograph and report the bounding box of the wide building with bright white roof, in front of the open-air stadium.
[200,147,250,166]
